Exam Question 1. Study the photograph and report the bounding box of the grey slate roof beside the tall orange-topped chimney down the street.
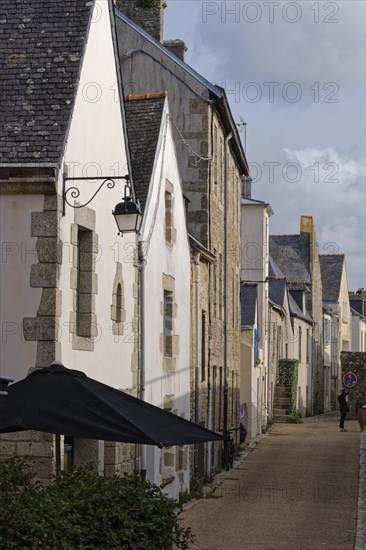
[269,235,310,283]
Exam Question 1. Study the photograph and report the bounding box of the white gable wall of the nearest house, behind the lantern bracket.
[59,0,136,389]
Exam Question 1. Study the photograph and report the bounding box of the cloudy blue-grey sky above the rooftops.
[164,0,366,290]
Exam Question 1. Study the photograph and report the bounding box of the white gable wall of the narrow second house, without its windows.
[141,101,190,497]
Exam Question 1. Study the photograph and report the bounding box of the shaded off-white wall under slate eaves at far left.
[0,195,43,380]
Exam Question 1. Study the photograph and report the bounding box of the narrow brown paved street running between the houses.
[178,413,360,550]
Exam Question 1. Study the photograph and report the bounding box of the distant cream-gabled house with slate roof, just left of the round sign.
[319,254,352,406]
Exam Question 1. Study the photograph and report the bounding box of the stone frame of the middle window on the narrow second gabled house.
[160,273,179,372]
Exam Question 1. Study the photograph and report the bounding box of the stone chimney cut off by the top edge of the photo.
[115,0,166,42]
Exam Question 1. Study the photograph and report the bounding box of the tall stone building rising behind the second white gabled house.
[116,3,249,478]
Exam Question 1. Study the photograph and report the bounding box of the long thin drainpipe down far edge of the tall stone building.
[224,133,233,433]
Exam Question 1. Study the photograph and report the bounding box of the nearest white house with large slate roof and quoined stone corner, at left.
[0,0,138,478]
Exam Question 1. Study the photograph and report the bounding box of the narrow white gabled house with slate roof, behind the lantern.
[125,92,191,498]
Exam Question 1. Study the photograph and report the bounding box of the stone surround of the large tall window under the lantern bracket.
[70,207,98,351]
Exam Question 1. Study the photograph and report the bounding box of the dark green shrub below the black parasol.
[0,458,192,550]
